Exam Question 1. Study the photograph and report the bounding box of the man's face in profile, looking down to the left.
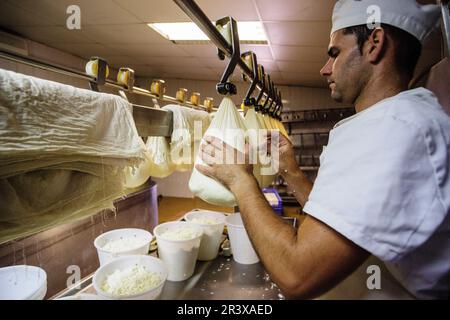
[320,30,370,104]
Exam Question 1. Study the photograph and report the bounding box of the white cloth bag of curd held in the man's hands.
[189,97,246,207]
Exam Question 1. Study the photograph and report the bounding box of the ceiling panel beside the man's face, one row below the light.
[272,45,328,63]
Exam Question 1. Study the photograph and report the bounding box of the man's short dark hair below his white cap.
[343,24,422,79]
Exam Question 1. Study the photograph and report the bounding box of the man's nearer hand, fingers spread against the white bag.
[195,136,253,190]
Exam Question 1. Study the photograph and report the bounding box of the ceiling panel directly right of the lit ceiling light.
[264,22,331,46]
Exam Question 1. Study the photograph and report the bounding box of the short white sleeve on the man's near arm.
[304,117,448,261]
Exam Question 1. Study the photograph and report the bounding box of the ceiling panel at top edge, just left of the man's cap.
[255,0,335,21]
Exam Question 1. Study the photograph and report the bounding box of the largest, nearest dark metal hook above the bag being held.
[216,17,241,95]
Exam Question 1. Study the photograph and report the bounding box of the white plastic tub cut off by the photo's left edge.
[0,265,47,300]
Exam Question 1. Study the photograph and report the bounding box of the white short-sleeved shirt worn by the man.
[304,88,450,298]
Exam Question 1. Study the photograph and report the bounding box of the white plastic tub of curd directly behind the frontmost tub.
[94,228,153,266]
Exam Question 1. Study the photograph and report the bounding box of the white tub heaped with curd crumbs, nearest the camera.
[92,255,167,300]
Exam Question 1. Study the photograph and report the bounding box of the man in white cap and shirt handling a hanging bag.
[197,0,450,298]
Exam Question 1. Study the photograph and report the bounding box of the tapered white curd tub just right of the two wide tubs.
[153,221,203,281]
